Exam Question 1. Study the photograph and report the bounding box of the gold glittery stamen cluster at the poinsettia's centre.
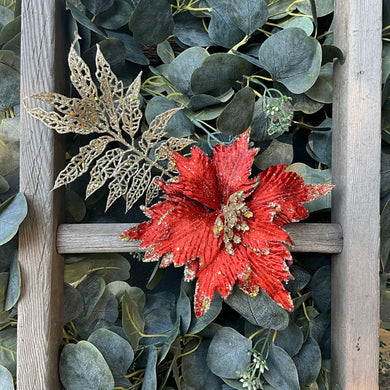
[214,191,253,255]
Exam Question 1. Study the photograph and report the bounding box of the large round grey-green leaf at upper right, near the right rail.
[259,28,322,94]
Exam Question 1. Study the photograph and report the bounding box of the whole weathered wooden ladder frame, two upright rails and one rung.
[17,0,381,390]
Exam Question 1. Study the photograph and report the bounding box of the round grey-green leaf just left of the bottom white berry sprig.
[207,327,252,379]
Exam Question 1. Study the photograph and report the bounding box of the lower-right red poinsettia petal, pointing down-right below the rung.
[238,243,294,310]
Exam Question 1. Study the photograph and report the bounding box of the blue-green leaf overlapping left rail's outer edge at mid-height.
[0,193,27,245]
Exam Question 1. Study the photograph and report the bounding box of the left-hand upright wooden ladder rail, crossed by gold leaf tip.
[17,0,64,390]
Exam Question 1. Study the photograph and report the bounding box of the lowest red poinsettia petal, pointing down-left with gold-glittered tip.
[194,249,248,318]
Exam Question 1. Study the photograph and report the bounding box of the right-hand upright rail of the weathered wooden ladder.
[331,0,382,390]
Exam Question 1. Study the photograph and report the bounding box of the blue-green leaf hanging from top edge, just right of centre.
[208,0,245,49]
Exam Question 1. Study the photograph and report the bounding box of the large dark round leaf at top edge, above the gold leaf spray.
[129,0,174,45]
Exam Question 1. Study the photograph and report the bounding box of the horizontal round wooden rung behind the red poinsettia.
[57,223,343,254]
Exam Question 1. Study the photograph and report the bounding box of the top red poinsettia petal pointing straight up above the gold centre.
[213,131,258,204]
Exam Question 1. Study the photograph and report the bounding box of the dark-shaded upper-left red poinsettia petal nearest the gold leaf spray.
[163,147,220,210]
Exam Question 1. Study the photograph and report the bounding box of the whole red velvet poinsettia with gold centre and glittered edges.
[121,131,333,317]
